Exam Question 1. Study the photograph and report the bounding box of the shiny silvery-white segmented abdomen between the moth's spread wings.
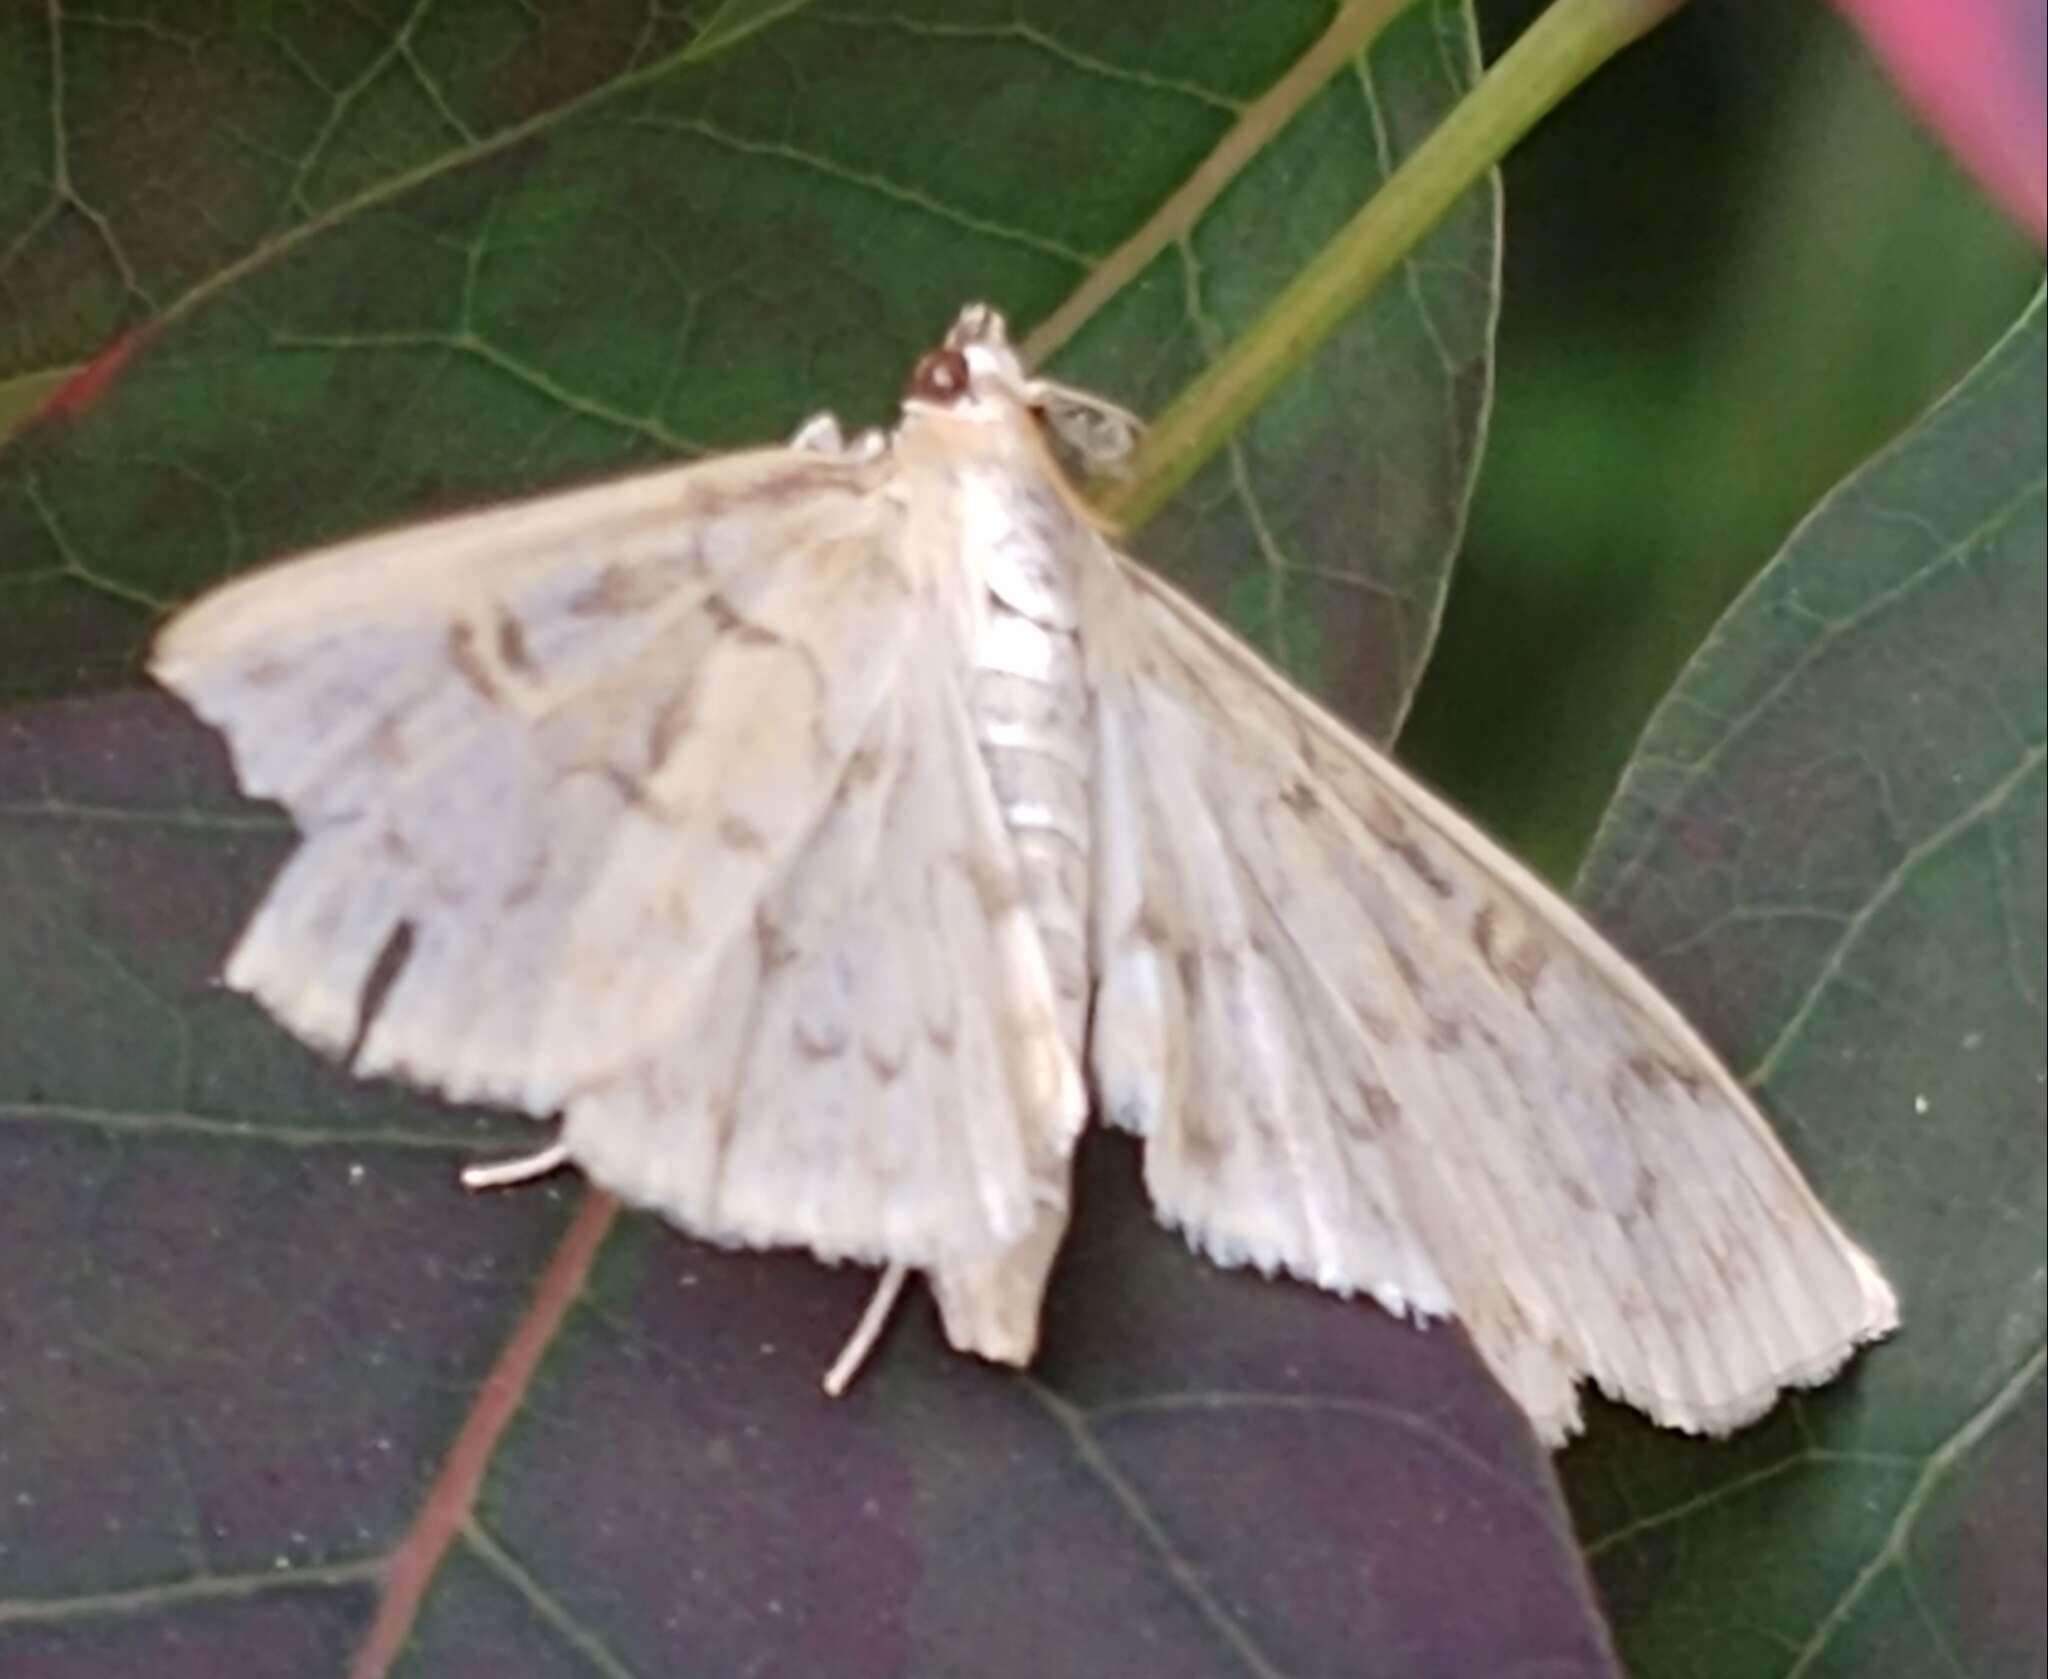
[973,600,1094,1059]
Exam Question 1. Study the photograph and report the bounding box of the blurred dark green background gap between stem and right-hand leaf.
[1401,0,2042,880]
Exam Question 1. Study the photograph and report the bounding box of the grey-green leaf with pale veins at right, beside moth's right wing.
[1567,297,2048,1679]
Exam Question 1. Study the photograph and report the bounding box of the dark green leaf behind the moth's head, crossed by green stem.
[0,0,1495,729]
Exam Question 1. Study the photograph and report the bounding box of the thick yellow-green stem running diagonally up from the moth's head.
[1090,0,1683,528]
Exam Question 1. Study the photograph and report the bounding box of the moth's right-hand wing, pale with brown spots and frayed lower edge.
[1094,559,1896,1441]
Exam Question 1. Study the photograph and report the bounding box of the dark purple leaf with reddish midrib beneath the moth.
[0,696,1612,1679]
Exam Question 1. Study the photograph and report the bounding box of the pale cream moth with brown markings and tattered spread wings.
[152,307,1896,1444]
